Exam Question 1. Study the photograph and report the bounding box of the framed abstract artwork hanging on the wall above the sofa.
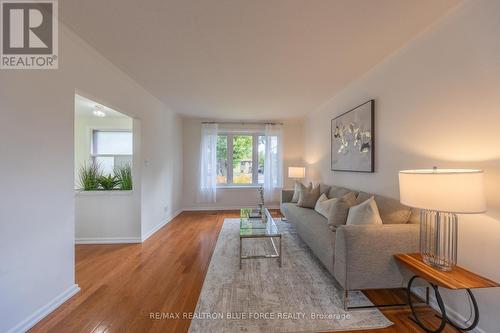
[331,100,375,172]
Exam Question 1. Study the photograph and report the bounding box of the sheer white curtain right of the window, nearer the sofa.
[264,124,283,202]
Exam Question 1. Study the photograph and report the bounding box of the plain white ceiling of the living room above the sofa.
[59,0,461,120]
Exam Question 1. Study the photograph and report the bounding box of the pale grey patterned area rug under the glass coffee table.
[189,219,393,333]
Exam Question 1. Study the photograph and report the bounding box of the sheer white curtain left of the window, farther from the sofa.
[197,124,217,203]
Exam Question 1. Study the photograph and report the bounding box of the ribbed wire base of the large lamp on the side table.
[420,210,458,271]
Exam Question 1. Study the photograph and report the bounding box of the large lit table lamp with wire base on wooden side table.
[399,168,486,271]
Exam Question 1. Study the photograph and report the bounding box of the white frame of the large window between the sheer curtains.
[217,131,265,188]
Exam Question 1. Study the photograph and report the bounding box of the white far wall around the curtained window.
[182,117,304,210]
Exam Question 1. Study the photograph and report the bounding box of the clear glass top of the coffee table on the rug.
[240,208,280,238]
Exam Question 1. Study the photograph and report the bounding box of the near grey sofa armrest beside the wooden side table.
[334,224,420,290]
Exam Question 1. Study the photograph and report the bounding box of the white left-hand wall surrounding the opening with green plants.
[0,24,182,332]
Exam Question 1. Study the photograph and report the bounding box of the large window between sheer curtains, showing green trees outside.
[217,133,278,186]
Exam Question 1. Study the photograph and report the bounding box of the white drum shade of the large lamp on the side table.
[399,169,486,214]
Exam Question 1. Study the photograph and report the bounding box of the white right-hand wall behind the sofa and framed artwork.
[305,0,500,332]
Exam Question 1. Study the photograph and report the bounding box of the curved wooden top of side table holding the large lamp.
[394,253,500,289]
